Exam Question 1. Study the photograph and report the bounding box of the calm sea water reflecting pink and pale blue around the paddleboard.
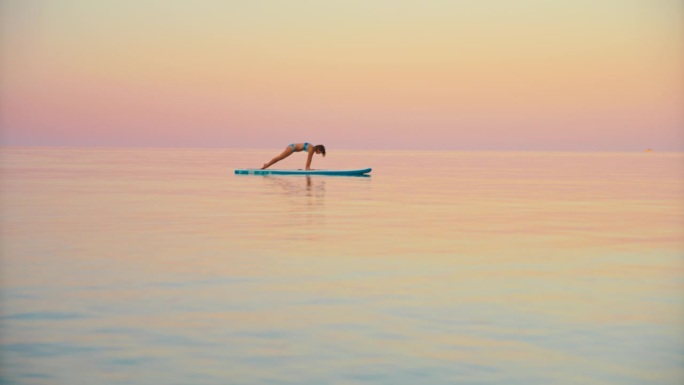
[0,146,684,385]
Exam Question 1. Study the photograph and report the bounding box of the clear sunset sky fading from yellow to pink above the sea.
[0,0,684,151]
